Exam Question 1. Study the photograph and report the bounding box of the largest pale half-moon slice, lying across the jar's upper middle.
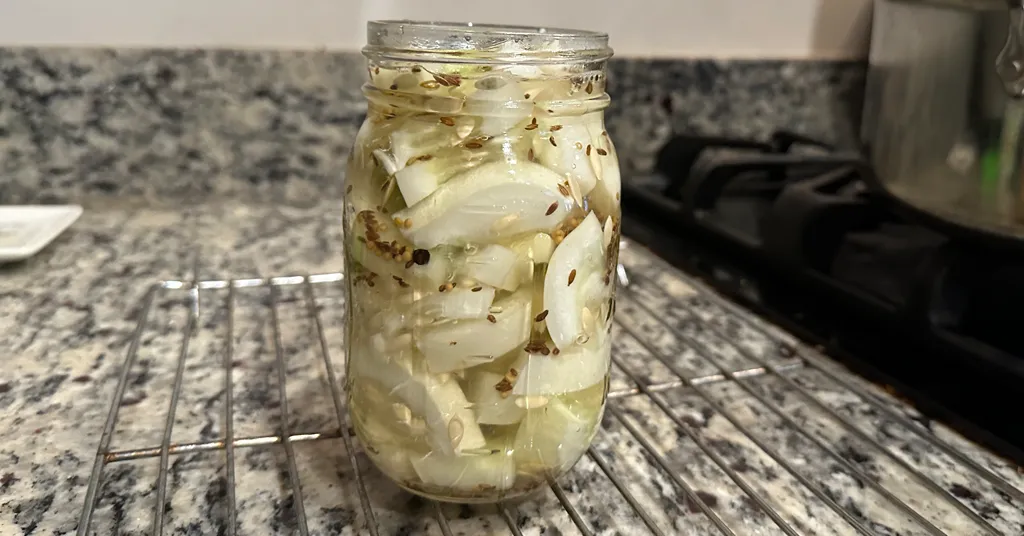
[395,161,572,249]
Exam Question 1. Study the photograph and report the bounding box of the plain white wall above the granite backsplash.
[0,0,871,58]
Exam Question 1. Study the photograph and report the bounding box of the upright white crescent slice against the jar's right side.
[544,212,610,352]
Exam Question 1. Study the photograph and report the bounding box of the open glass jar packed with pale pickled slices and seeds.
[344,22,621,502]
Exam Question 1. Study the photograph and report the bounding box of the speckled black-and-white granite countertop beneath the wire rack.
[0,201,1024,535]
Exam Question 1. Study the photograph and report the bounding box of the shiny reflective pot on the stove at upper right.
[861,0,1024,242]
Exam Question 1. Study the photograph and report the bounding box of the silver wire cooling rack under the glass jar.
[78,249,1024,536]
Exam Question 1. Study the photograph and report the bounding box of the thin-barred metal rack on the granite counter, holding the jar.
[78,252,1024,536]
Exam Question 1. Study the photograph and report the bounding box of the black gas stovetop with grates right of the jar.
[623,132,1024,463]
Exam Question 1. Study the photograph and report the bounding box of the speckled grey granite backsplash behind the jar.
[0,47,865,206]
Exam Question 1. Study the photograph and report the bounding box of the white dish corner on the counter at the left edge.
[0,205,82,262]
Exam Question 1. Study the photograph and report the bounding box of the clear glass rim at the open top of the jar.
[362,19,612,64]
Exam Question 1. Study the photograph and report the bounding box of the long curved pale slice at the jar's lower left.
[349,348,484,455]
